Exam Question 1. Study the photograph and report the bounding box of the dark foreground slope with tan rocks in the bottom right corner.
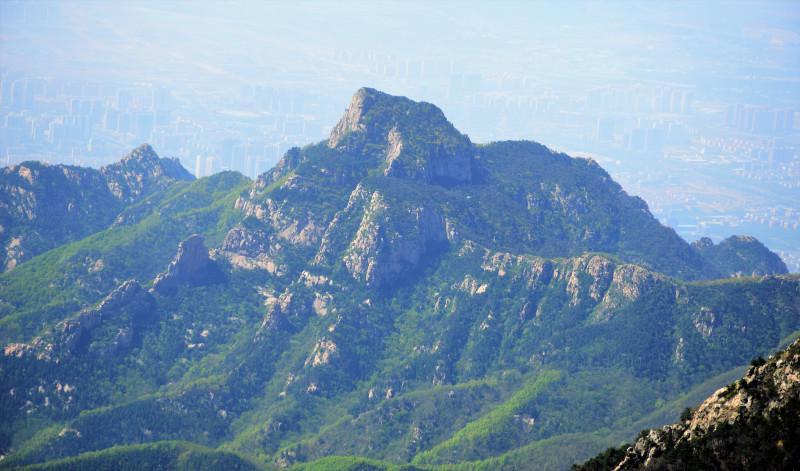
[574,341,800,471]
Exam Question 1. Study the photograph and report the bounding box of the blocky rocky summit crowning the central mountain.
[328,88,476,183]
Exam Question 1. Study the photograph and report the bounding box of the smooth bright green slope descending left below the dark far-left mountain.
[0,172,249,342]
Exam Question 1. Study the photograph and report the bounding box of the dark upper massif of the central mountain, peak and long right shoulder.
[239,89,718,284]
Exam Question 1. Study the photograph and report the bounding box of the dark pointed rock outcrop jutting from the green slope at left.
[152,234,224,294]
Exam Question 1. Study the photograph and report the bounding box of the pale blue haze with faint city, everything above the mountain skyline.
[0,1,800,270]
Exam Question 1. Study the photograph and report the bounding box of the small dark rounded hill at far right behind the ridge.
[692,236,789,277]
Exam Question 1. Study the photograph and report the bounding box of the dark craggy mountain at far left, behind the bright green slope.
[0,144,194,271]
